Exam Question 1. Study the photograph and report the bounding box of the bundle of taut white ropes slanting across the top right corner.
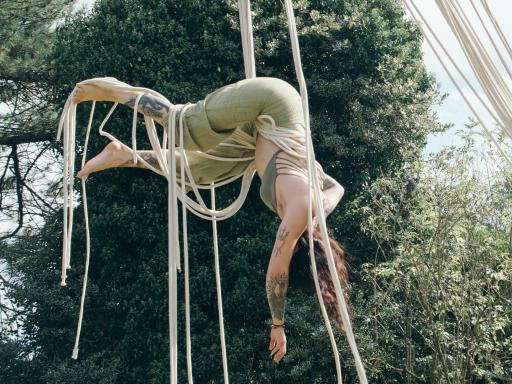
[404,0,512,166]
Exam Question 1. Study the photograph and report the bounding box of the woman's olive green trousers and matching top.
[167,77,320,213]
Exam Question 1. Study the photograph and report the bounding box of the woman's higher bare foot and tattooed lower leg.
[73,81,171,124]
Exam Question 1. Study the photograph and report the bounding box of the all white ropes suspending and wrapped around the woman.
[57,0,367,384]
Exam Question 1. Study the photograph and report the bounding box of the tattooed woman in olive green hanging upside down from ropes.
[73,77,347,363]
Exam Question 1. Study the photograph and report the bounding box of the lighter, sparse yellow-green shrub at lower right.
[354,142,512,383]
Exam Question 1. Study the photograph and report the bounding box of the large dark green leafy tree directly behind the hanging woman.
[3,0,442,383]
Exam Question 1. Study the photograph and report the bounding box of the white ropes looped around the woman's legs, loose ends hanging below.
[57,78,256,384]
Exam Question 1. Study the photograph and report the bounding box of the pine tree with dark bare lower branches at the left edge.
[0,0,72,241]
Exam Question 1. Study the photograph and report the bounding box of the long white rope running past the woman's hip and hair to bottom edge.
[285,0,367,384]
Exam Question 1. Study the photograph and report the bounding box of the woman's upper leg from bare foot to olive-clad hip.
[73,77,303,152]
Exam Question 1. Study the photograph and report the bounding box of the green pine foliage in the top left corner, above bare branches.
[0,0,72,145]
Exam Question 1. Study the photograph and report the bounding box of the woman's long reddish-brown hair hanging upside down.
[290,226,349,331]
